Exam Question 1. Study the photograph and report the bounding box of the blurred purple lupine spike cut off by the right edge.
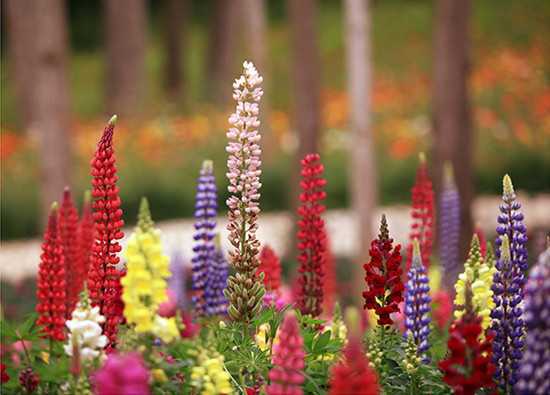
[515,243,550,395]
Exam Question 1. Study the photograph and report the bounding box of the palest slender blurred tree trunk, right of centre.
[345,0,378,304]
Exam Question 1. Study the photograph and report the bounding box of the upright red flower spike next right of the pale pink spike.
[297,154,326,317]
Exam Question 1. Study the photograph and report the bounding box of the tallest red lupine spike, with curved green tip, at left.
[88,115,124,348]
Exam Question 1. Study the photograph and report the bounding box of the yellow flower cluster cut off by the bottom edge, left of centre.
[191,350,233,395]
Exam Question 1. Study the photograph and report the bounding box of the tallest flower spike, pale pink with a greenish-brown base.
[225,62,265,322]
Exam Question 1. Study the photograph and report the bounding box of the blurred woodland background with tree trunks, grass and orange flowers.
[0,0,550,318]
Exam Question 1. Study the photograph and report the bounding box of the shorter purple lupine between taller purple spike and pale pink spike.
[204,235,229,316]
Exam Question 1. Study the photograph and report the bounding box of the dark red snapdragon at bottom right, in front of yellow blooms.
[439,283,495,395]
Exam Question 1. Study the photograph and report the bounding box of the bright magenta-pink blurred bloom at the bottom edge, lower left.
[93,353,151,395]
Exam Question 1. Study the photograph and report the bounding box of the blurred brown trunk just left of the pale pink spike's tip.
[206,0,239,104]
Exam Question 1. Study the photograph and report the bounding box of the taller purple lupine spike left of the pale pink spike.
[191,160,218,317]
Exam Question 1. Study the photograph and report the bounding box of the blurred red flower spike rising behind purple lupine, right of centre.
[407,152,435,269]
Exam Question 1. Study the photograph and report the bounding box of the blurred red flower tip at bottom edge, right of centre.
[329,339,380,395]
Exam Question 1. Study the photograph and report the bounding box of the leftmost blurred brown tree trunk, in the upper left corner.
[5,0,36,129]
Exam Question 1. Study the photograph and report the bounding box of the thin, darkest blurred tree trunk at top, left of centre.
[163,0,189,101]
